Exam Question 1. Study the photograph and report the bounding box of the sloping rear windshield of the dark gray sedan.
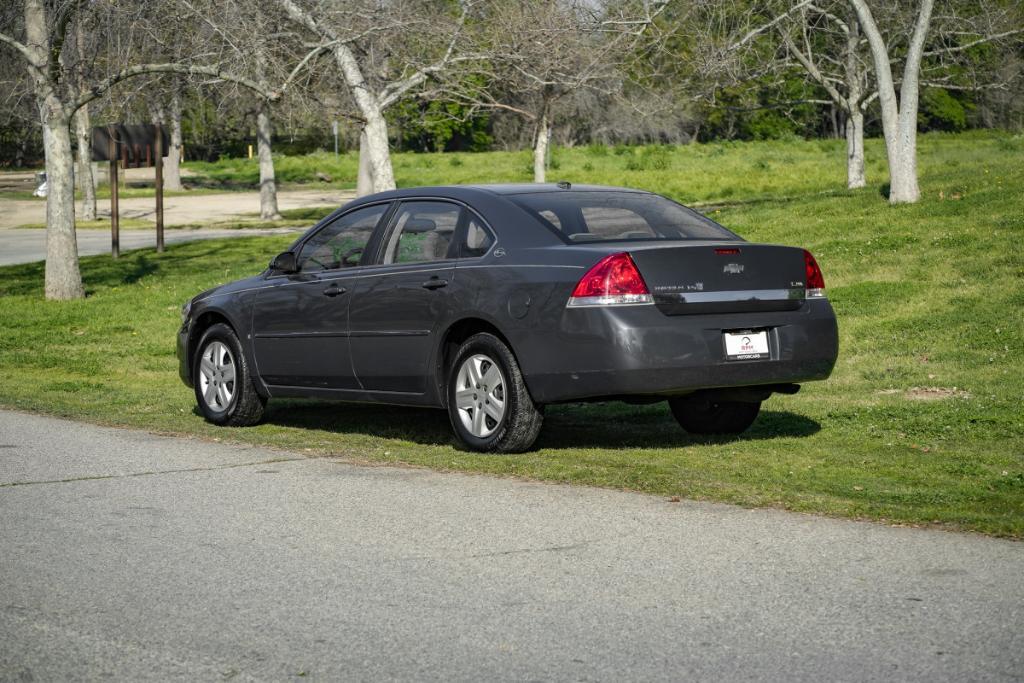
[509,190,739,242]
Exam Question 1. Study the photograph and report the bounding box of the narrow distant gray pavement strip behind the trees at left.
[0,227,303,265]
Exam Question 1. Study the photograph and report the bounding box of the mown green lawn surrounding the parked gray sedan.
[0,134,1024,538]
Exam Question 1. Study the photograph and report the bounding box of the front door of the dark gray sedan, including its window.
[253,203,390,390]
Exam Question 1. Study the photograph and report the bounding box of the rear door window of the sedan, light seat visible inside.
[384,202,462,263]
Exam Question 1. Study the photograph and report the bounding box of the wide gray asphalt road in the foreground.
[0,408,1024,681]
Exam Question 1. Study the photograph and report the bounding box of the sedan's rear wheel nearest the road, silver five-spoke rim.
[446,333,544,453]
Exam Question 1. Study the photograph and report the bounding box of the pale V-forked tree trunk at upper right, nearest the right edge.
[850,0,933,204]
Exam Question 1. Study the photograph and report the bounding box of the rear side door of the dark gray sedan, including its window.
[349,200,463,395]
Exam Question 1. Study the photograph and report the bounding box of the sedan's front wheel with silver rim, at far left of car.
[193,323,266,427]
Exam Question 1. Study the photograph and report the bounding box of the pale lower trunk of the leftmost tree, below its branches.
[41,112,85,300]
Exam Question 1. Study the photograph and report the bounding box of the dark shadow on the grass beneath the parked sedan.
[258,399,821,450]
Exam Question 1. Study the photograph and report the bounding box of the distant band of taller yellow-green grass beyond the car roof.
[186,127,1024,204]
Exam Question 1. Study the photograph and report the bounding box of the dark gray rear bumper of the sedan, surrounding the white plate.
[523,299,839,403]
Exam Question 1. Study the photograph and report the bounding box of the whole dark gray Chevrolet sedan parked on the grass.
[177,183,838,453]
